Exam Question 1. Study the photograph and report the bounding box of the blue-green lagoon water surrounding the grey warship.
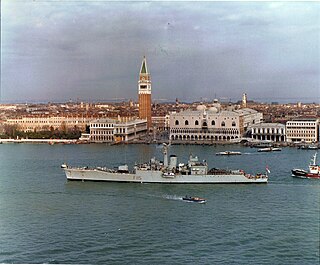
[0,144,320,265]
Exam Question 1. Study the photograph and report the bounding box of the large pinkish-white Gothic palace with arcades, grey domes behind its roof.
[169,101,262,142]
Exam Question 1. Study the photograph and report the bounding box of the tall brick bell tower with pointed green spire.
[138,56,151,129]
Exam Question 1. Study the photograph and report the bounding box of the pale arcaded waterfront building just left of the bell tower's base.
[90,118,147,143]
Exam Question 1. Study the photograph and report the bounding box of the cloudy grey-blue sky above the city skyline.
[0,0,320,103]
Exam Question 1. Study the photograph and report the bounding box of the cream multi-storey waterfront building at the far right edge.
[286,118,320,143]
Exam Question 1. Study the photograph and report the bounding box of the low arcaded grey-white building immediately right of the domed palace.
[250,123,286,142]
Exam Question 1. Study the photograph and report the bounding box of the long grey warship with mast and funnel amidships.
[61,144,268,184]
